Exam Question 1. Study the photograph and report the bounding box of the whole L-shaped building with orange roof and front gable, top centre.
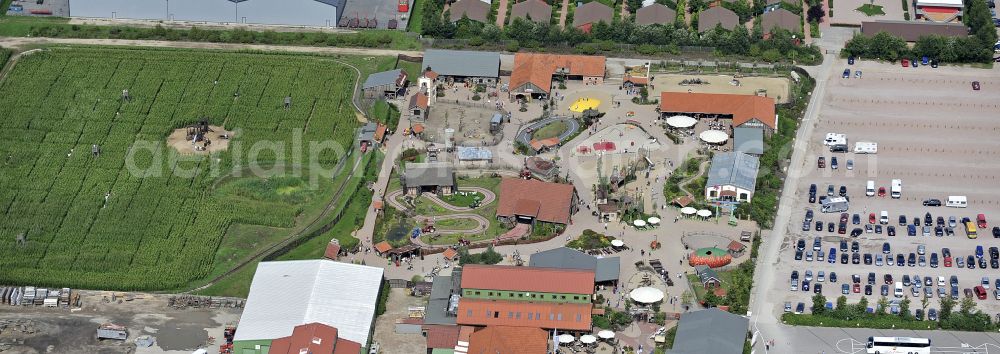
[510,53,606,99]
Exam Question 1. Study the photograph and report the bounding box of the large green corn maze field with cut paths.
[0,48,358,290]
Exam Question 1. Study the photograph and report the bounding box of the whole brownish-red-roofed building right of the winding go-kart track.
[497,178,579,225]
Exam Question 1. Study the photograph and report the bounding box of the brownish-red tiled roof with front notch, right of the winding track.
[497,178,575,224]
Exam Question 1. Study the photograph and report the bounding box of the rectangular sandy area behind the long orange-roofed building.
[649,74,790,103]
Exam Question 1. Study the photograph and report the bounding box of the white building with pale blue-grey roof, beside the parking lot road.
[705,152,760,202]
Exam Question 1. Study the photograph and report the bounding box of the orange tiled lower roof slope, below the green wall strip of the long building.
[456,298,592,332]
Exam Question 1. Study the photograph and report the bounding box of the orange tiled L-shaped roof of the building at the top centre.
[510,53,606,92]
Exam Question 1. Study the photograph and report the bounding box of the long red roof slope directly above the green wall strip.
[462,264,594,294]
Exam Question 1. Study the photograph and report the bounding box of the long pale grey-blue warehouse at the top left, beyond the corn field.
[69,0,348,27]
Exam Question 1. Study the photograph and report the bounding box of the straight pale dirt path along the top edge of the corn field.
[0,37,423,56]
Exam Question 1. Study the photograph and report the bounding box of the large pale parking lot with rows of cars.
[769,61,1000,314]
